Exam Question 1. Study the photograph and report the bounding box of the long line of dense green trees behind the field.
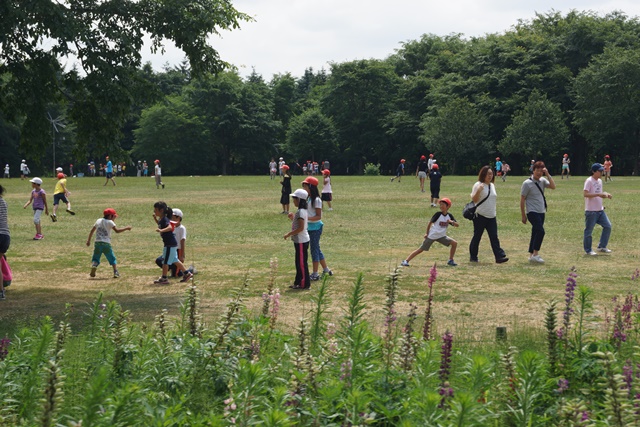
[0,7,640,175]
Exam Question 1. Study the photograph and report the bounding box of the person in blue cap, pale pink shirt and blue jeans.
[582,163,611,256]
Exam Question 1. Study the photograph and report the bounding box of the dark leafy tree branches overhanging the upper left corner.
[0,0,250,158]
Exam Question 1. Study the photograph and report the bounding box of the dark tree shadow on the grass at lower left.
[0,288,184,337]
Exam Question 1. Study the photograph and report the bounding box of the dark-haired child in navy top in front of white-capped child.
[153,202,193,285]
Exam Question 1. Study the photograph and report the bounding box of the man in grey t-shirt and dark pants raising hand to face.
[520,161,556,264]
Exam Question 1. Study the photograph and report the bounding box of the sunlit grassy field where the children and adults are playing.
[0,172,640,340]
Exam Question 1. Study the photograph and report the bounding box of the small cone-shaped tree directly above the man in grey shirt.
[498,90,569,161]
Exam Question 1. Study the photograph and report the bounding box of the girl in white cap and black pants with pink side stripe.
[284,188,311,289]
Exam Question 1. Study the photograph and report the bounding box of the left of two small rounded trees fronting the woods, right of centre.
[420,98,491,174]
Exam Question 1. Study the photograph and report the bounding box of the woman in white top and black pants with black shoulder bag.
[469,166,509,264]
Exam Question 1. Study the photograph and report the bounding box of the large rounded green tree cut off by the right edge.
[573,47,640,175]
